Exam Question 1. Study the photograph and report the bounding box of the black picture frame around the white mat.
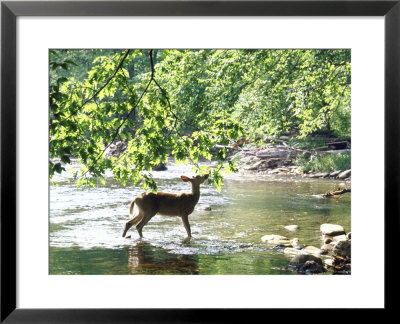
[0,0,400,323]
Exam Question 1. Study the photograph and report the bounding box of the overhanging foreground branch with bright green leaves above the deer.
[49,50,241,190]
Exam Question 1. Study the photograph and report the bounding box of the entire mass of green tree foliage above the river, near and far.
[49,50,351,190]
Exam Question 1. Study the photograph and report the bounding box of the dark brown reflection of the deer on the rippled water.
[128,242,199,274]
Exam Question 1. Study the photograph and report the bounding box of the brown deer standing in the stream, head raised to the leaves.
[122,174,208,240]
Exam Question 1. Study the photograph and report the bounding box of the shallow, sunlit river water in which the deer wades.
[49,161,351,274]
